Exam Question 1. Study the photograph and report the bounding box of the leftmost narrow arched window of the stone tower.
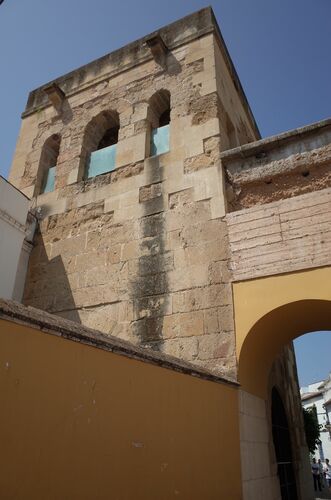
[36,134,61,194]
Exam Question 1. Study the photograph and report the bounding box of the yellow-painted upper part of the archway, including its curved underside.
[233,267,331,397]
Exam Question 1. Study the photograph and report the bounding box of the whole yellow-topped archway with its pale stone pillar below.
[233,274,331,500]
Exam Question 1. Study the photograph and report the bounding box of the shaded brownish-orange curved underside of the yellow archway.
[238,299,331,399]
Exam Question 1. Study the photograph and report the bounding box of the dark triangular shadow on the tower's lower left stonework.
[23,230,81,323]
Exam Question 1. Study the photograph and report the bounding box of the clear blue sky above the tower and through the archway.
[0,0,331,383]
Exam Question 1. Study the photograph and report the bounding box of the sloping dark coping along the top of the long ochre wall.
[0,299,239,387]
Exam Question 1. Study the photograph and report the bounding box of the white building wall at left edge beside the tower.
[0,176,29,299]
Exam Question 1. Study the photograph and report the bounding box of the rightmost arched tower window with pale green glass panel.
[148,90,170,156]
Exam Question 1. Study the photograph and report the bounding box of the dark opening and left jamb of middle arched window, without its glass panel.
[79,110,120,179]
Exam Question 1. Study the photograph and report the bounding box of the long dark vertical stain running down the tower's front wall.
[132,158,172,350]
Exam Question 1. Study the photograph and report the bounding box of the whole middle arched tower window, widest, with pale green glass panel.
[81,111,119,178]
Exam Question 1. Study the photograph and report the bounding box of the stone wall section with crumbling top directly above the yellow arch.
[221,120,331,281]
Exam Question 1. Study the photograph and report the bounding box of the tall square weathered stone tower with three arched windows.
[10,8,260,376]
